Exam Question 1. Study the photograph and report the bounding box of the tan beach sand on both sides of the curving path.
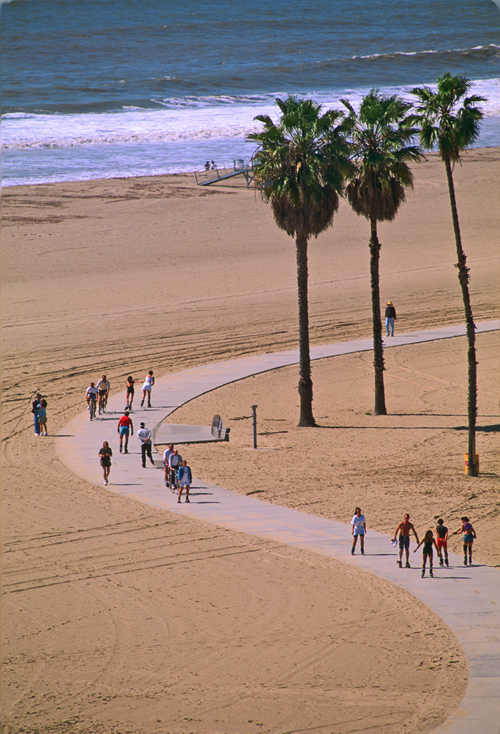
[2,149,500,734]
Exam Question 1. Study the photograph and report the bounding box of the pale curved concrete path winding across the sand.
[56,321,500,734]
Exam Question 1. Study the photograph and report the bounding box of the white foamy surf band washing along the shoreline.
[2,80,500,186]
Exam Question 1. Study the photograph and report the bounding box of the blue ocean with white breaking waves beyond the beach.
[1,0,500,186]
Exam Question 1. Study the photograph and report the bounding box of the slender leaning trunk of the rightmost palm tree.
[444,158,477,477]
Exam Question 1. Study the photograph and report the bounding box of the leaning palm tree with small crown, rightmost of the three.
[412,74,485,477]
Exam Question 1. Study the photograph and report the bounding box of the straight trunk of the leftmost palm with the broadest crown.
[295,234,316,426]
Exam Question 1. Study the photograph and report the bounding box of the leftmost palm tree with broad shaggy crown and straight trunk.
[248,96,349,426]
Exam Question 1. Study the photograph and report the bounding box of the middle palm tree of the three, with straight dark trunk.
[342,89,422,415]
